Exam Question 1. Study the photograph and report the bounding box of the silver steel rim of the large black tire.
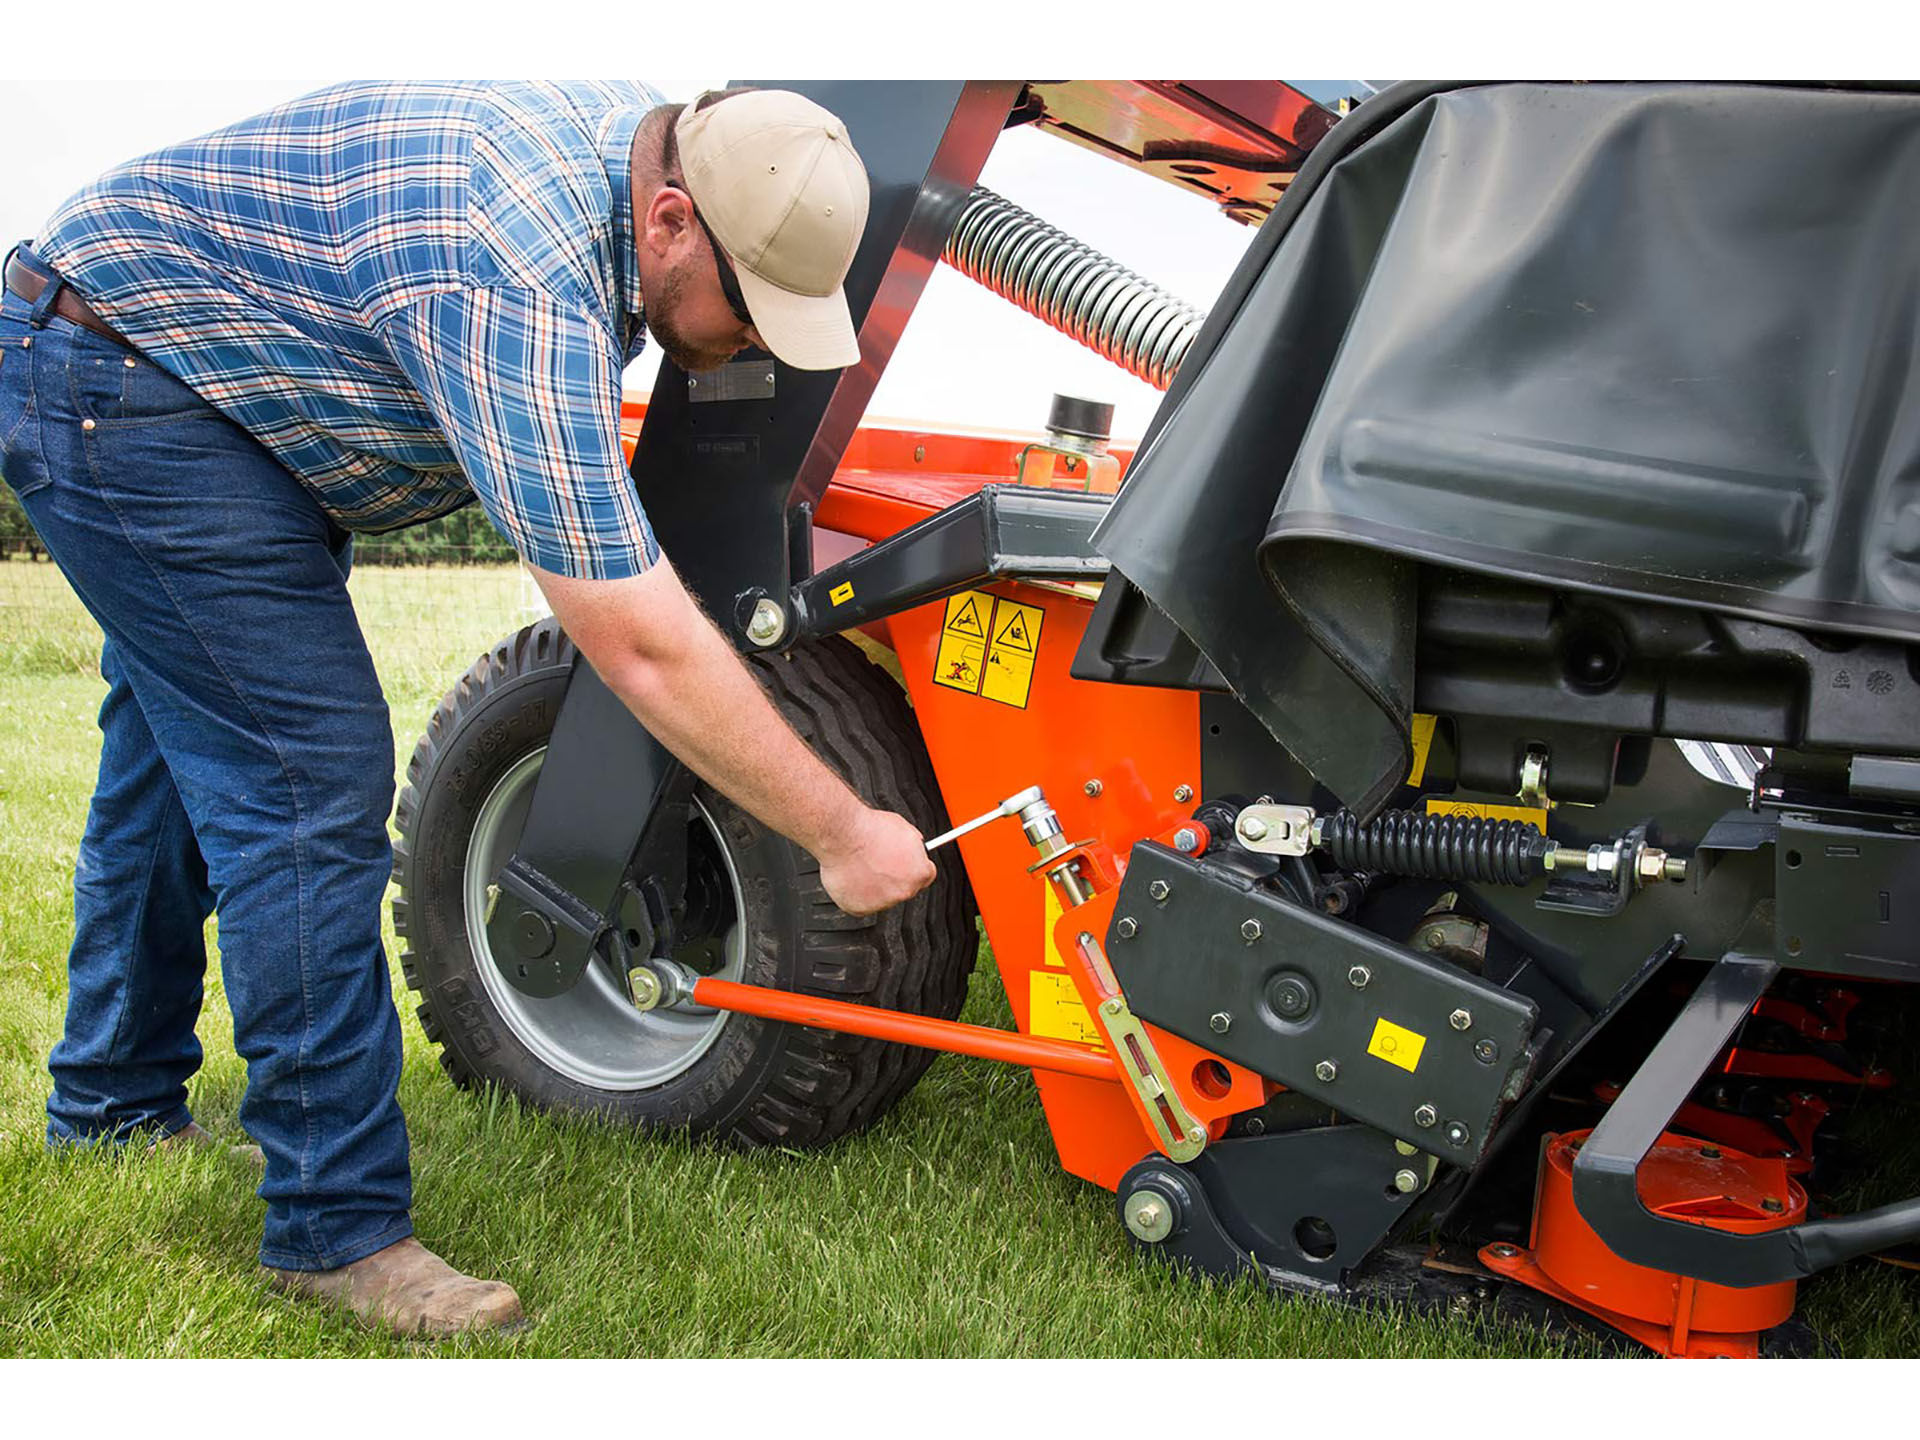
[463,745,747,1091]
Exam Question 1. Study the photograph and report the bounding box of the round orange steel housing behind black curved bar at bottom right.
[1480,1131,1807,1357]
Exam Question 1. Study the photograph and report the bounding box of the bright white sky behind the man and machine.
[0,69,1282,438]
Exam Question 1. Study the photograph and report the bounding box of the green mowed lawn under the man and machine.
[0,561,1920,1356]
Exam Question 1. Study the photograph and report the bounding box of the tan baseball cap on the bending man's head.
[674,90,868,371]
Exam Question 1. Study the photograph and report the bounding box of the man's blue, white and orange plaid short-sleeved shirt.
[35,83,662,580]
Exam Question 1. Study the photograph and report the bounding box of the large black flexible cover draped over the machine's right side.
[1096,84,1920,812]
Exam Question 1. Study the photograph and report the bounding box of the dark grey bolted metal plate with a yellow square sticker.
[1106,841,1538,1165]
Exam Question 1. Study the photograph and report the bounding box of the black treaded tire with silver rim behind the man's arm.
[394,620,977,1146]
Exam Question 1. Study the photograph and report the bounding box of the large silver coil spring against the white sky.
[945,186,1206,390]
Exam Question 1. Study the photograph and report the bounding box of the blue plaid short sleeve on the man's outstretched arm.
[380,286,660,580]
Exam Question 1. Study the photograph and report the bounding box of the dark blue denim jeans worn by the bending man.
[0,270,413,1269]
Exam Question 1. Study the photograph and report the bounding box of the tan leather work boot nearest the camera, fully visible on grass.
[263,1236,526,1336]
